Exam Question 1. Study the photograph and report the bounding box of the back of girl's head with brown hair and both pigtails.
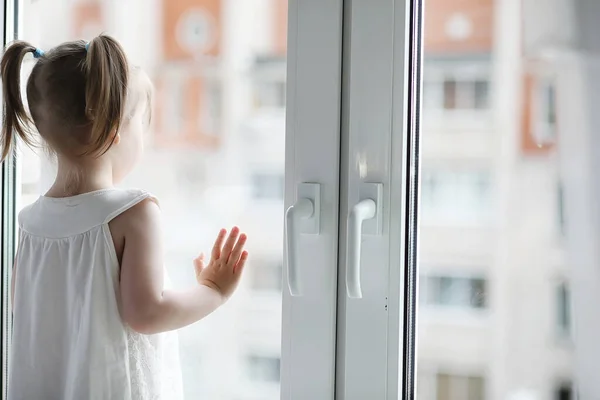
[0,35,150,160]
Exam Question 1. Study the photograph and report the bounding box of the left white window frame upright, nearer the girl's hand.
[281,0,344,400]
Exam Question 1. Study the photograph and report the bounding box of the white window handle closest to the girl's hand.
[285,183,321,297]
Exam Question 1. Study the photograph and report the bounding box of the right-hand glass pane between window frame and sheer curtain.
[416,0,576,400]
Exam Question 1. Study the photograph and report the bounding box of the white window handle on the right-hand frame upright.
[346,183,383,299]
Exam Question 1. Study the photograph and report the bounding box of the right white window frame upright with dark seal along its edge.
[336,0,423,400]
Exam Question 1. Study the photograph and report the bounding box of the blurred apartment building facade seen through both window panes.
[15,0,572,400]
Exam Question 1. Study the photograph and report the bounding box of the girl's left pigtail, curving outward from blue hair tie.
[0,41,36,161]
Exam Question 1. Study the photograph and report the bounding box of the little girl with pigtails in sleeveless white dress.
[0,36,248,400]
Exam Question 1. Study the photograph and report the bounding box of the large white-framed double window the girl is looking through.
[7,0,600,400]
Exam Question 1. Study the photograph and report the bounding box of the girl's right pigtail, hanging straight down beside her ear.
[85,35,129,154]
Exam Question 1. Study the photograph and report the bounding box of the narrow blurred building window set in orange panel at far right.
[532,78,557,145]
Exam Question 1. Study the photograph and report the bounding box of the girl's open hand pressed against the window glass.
[194,227,248,299]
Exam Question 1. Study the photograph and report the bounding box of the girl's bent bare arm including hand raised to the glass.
[120,200,247,334]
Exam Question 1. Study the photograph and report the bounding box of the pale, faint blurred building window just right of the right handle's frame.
[421,168,491,224]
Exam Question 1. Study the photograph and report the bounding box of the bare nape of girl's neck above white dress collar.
[46,159,114,197]
